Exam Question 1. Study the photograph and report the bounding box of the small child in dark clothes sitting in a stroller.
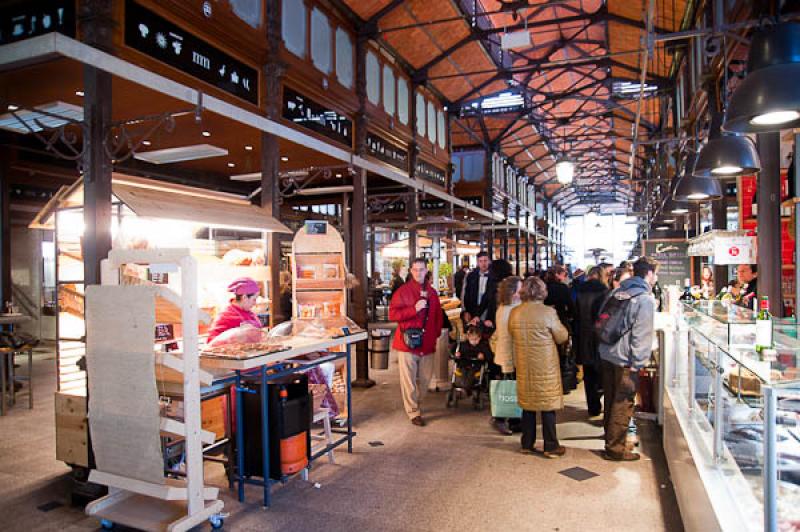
[447,325,494,410]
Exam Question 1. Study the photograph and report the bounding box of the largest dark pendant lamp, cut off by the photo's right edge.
[722,22,800,133]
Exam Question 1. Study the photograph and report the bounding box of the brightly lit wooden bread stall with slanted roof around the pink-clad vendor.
[31,174,289,467]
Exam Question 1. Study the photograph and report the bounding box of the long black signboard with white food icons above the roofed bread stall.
[125,0,258,105]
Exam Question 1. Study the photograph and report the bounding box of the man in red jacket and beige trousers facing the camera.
[389,258,442,427]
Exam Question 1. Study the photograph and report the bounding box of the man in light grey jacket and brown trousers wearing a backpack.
[598,257,658,461]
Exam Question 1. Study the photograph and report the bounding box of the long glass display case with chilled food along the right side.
[665,301,800,530]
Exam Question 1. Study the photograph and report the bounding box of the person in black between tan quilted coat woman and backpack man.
[575,266,608,417]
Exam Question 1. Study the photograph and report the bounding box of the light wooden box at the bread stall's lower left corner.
[55,392,89,467]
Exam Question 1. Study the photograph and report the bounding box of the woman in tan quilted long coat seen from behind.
[508,277,569,458]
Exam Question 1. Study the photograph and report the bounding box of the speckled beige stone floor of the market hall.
[0,352,682,532]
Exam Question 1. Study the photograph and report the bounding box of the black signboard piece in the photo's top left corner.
[0,0,75,45]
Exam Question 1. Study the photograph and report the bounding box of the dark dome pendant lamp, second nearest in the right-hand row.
[692,135,761,177]
